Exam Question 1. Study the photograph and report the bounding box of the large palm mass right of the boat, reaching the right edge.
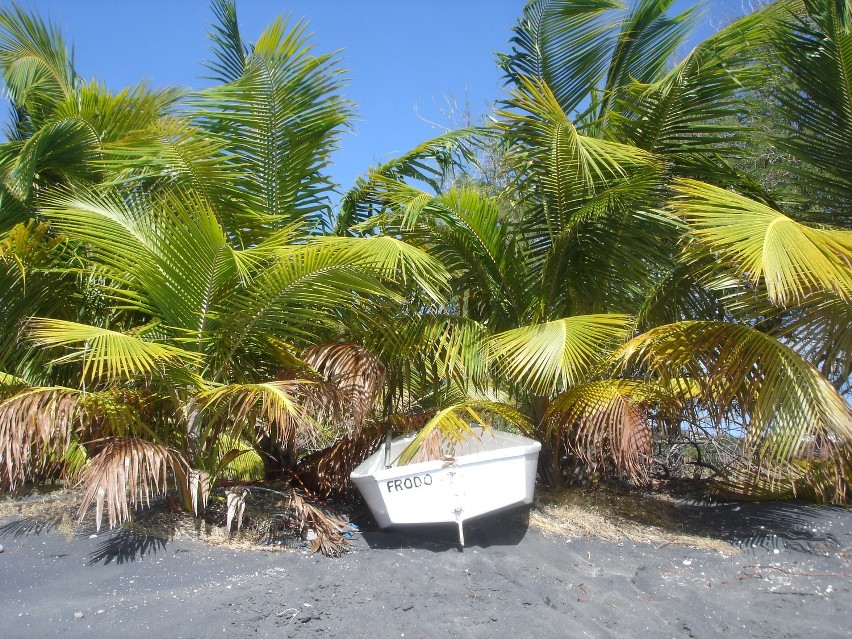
[342,0,852,500]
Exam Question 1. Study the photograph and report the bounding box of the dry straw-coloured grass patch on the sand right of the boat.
[530,489,737,554]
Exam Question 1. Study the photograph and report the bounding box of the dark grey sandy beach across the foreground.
[0,504,852,639]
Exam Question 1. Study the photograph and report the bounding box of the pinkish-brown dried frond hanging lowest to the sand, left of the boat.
[80,437,188,530]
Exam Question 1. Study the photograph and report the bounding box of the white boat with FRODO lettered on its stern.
[351,428,541,546]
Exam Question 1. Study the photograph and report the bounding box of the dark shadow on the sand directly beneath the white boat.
[360,507,530,552]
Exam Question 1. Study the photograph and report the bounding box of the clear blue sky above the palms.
[11,0,743,194]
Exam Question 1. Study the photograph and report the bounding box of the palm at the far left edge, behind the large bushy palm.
[0,5,188,381]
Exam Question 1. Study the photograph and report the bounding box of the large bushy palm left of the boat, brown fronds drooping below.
[0,0,444,544]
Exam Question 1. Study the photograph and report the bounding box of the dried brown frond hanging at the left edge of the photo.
[0,387,83,490]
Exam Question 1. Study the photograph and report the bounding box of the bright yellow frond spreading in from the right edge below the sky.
[672,180,852,306]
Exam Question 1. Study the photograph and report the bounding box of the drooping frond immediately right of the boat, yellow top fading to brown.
[548,380,653,483]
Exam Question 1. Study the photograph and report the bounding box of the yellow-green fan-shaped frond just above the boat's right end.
[488,314,633,395]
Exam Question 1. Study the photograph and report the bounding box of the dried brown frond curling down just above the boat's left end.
[303,343,385,428]
